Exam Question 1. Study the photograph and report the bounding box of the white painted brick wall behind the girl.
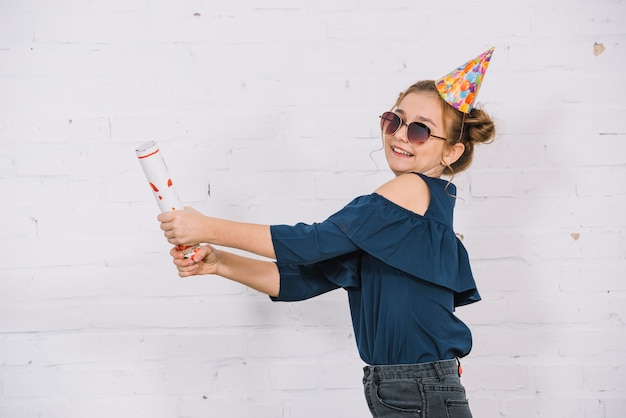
[0,0,626,418]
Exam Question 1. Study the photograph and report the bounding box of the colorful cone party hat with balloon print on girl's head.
[435,47,495,113]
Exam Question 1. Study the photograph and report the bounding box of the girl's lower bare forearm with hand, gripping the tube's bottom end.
[170,245,280,297]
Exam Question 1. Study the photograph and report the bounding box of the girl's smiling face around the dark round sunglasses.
[383,92,446,177]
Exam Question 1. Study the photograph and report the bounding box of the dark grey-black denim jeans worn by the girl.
[363,360,472,418]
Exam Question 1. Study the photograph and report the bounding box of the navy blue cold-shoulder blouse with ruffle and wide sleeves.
[271,174,480,365]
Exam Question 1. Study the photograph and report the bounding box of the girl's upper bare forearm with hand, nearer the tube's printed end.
[157,207,276,258]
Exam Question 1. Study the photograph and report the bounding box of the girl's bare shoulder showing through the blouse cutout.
[376,173,430,215]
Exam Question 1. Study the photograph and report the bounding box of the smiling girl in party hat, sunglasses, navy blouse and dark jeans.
[158,48,495,418]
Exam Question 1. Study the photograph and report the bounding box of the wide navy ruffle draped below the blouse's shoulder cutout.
[328,193,480,306]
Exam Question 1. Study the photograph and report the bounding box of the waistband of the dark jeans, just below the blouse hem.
[363,359,460,379]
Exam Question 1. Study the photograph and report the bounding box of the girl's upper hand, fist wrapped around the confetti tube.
[157,206,206,247]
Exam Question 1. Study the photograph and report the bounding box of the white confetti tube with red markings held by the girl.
[135,141,198,258]
